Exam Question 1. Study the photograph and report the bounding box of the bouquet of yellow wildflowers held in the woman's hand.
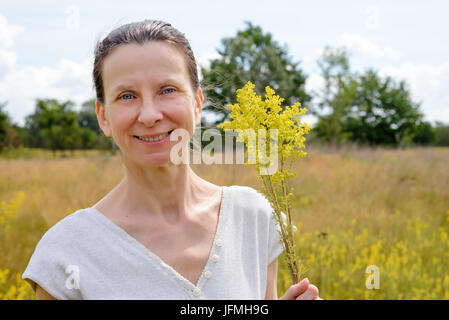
[217,82,311,284]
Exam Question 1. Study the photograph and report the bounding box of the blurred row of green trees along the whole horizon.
[0,22,449,152]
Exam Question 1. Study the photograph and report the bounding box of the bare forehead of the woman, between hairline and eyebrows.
[102,41,189,93]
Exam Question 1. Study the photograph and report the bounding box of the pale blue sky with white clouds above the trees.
[0,0,449,125]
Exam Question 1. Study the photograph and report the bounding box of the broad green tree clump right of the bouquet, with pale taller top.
[315,48,423,146]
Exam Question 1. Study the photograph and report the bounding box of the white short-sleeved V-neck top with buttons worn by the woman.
[22,185,283,300]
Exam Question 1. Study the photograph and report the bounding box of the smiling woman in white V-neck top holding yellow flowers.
[22,20,318,299]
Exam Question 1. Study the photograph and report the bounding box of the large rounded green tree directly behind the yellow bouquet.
[201,22,310,124]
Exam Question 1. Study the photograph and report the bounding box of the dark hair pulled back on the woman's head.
[92,20,200,104]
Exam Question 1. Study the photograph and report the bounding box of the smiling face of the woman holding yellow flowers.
[96,41,203,165]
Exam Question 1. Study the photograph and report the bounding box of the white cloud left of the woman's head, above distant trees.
[0,14,94,125]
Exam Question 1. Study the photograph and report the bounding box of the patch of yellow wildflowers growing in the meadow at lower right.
[278,212,449,300]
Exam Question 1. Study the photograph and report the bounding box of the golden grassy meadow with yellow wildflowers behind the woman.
[0,145,449,299]
